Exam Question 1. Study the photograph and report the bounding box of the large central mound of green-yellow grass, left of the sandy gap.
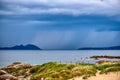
[30,62,97,80]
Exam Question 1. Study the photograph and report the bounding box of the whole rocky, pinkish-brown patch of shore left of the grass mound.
[0,62,33,80]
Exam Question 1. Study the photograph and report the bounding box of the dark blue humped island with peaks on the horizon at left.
[0,44,41,50]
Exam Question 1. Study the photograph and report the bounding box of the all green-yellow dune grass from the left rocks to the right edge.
[30,62,120,80]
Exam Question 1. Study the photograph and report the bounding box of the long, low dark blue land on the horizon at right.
[78,46,120,50]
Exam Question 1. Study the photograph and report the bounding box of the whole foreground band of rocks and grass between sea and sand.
[0,61,120,80]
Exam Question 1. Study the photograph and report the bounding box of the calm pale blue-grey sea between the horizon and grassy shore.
[0,50,120,67]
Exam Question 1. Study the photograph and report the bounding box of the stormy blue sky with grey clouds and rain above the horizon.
[0,0,120,50]
